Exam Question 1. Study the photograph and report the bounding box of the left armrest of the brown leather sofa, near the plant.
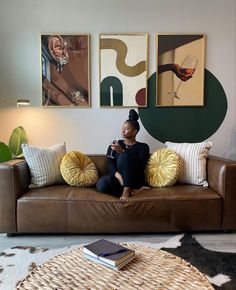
[0,159,30,233]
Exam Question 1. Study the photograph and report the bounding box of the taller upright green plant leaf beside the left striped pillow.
[9,126,28,157]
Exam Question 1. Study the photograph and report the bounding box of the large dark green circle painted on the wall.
[138,69,227,143]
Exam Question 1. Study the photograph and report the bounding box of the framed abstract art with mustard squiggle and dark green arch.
[99,33,148,107]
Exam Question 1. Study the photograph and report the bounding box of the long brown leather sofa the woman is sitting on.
[0,155,236,235]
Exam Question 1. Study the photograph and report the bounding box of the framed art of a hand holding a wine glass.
[156,34,205,107]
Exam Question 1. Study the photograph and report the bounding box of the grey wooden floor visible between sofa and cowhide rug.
[0,232,236,253]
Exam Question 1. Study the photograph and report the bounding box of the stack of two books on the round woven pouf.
[83,239,135,270]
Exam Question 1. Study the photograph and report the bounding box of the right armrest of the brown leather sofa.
[207,156,236,230]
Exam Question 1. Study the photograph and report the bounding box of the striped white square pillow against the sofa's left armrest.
[21,144,66,188]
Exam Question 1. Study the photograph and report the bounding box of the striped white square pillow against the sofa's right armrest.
[165,141,212,186]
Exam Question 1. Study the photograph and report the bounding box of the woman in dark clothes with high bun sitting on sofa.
[97,109,150,201]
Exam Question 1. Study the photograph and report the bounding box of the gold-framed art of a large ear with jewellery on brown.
[41,34,90,107]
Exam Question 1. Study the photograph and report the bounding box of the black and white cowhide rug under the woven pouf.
[0,234,236,290]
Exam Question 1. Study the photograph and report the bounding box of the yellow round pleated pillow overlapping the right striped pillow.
[145,148,181,187]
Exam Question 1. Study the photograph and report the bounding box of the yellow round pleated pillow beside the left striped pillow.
[60,151,98,187]
